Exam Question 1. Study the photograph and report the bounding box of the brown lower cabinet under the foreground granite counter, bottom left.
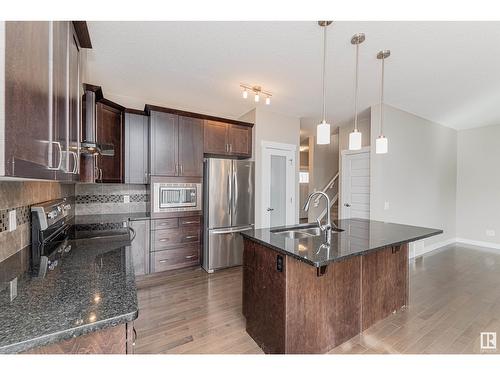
[24,322,136,354]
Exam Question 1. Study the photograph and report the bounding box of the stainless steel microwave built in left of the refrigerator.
[153,182,202,213]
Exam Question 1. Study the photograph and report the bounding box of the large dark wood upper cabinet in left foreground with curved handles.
[0,21,86,181]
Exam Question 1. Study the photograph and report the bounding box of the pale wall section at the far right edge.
[457,125,500,247]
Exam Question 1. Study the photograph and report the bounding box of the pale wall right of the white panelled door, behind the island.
[370,105,457,247]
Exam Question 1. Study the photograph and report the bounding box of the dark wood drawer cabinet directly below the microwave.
[151,216,201,272]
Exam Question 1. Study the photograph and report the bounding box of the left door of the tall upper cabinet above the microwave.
[149,111,179,176]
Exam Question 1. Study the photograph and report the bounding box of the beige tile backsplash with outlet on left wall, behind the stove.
[0,181,75,262]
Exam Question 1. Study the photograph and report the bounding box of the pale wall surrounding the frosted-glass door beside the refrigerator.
[240,107,300,228]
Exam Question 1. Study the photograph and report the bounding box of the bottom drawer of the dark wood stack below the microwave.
[151,244,200,272]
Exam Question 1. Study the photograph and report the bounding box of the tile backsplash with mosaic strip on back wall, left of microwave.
[75,184,149,215]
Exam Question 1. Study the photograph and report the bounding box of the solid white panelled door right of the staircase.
[340,148,370,219]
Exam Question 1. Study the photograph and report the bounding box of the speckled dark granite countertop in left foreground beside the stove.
[0,239,138,353]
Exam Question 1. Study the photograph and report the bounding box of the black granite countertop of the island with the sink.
[241,219,443,267]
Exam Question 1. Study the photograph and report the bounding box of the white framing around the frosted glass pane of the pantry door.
[260,141,297,228]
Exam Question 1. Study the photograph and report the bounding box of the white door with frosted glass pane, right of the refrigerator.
[261,142,296,228]
